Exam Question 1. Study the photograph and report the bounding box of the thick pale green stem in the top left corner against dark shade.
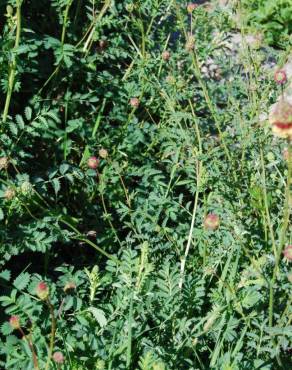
[2,0,21,123]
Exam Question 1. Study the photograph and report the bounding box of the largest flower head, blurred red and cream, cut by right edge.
[269,99,292,138]
